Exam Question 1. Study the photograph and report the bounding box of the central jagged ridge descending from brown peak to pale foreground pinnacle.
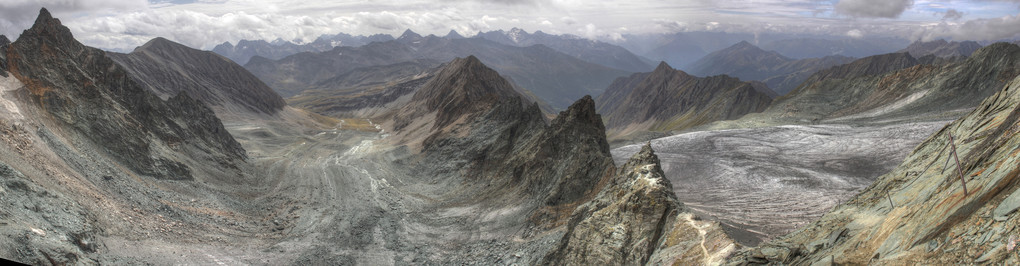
[385,57,736,265]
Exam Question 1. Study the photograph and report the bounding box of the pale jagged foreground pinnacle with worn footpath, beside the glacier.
[544,145,736,265]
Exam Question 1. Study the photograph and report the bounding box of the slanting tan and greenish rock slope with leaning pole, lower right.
[730,70,1020,265]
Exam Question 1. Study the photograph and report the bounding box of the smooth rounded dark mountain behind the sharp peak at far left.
[108,38,287,114]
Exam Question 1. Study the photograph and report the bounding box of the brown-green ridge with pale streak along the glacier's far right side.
[762,43,1020,124]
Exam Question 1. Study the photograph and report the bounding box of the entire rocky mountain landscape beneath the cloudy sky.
[0,8,1020,265]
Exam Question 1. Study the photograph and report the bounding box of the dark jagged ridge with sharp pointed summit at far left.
[6,9,246,179]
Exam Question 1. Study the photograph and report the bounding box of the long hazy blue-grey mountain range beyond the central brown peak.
[245,36,626,108]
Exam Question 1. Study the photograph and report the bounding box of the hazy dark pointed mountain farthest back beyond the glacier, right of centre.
[690,42,853,95]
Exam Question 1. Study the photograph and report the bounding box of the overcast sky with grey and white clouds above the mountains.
[0,0,1020,50]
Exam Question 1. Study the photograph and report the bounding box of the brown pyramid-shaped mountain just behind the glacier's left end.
[597,62,775,137]
